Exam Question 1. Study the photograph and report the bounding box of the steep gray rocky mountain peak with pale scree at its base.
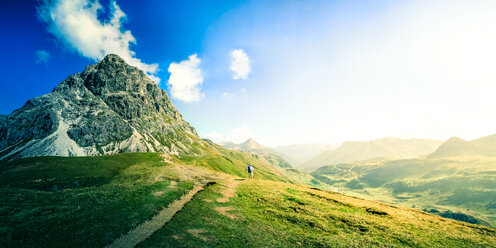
[0,54,210,160]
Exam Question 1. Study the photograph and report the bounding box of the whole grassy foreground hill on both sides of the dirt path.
[0,152,496,247]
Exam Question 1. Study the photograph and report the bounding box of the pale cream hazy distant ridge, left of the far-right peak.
[300,138,441,171]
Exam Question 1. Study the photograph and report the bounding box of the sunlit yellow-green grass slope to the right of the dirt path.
[138,180,496,248]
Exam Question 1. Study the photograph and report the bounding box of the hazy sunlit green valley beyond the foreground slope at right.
[312,156,496,227]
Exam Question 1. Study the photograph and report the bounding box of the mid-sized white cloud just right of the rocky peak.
[168,54,204,102]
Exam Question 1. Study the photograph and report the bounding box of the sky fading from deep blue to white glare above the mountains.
[0,0,496,145]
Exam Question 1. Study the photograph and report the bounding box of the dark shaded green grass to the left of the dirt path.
[0,153,193,247]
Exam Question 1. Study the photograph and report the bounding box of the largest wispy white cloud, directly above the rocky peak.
[37,0,160,83]
